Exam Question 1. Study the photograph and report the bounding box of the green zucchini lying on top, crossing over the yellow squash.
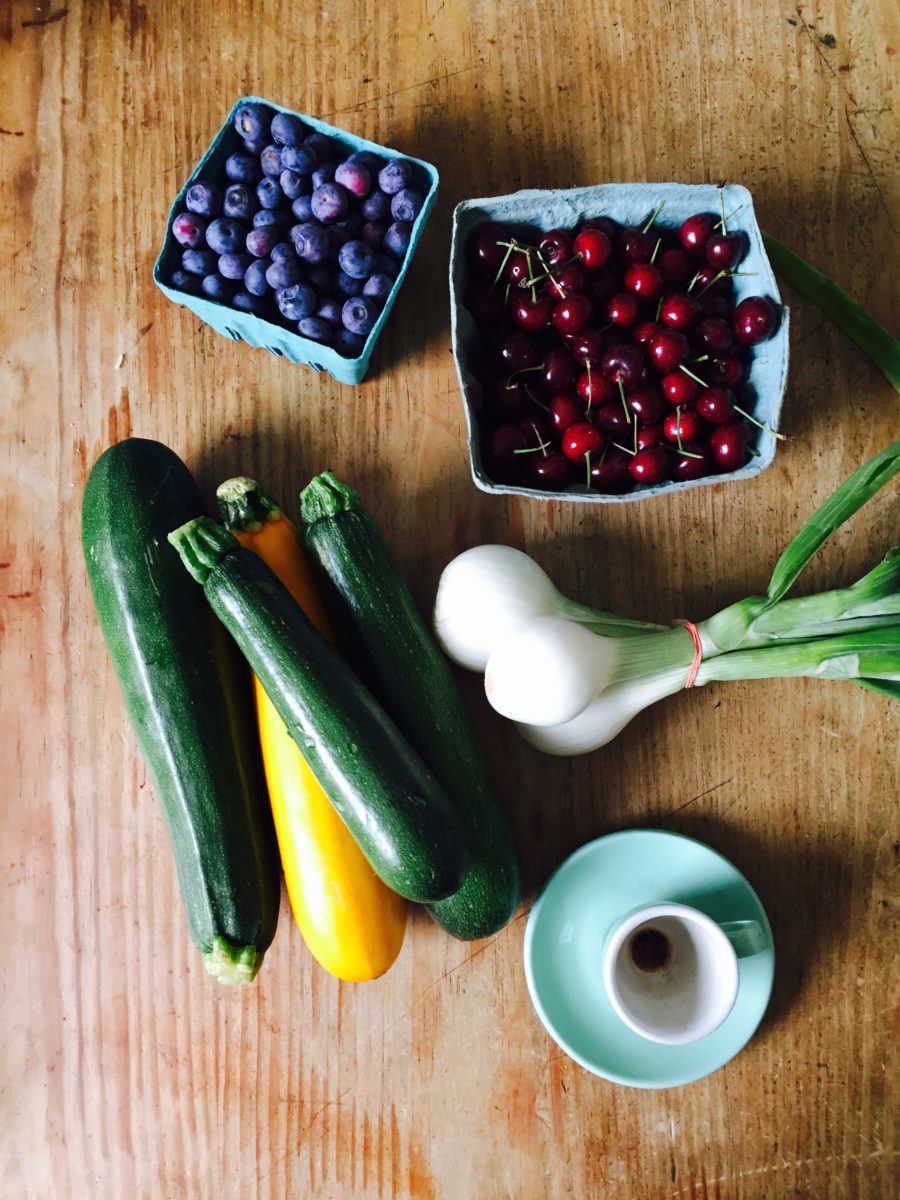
[169,517,468,900]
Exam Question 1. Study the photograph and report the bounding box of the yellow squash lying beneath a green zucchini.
[217,476,407,983]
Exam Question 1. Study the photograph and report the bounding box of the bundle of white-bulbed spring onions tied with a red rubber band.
[434,442,900,755]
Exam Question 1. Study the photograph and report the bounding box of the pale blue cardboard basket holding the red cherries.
[450,184,788,504]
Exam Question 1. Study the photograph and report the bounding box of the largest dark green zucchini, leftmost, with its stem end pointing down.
[82,438,281,983]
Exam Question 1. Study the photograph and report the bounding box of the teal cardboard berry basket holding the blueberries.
[154,96,439,384]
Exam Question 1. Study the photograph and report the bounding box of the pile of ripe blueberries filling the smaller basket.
[169,103,425,358]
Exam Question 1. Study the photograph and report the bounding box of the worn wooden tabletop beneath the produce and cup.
[0,0,900,1200]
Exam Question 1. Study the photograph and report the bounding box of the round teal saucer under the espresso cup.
[524,829,775,1087]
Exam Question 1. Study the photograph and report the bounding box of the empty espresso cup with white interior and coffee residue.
[602,904,766,1045]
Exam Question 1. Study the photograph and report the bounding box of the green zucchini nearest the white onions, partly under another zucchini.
[300,472,521,941]
